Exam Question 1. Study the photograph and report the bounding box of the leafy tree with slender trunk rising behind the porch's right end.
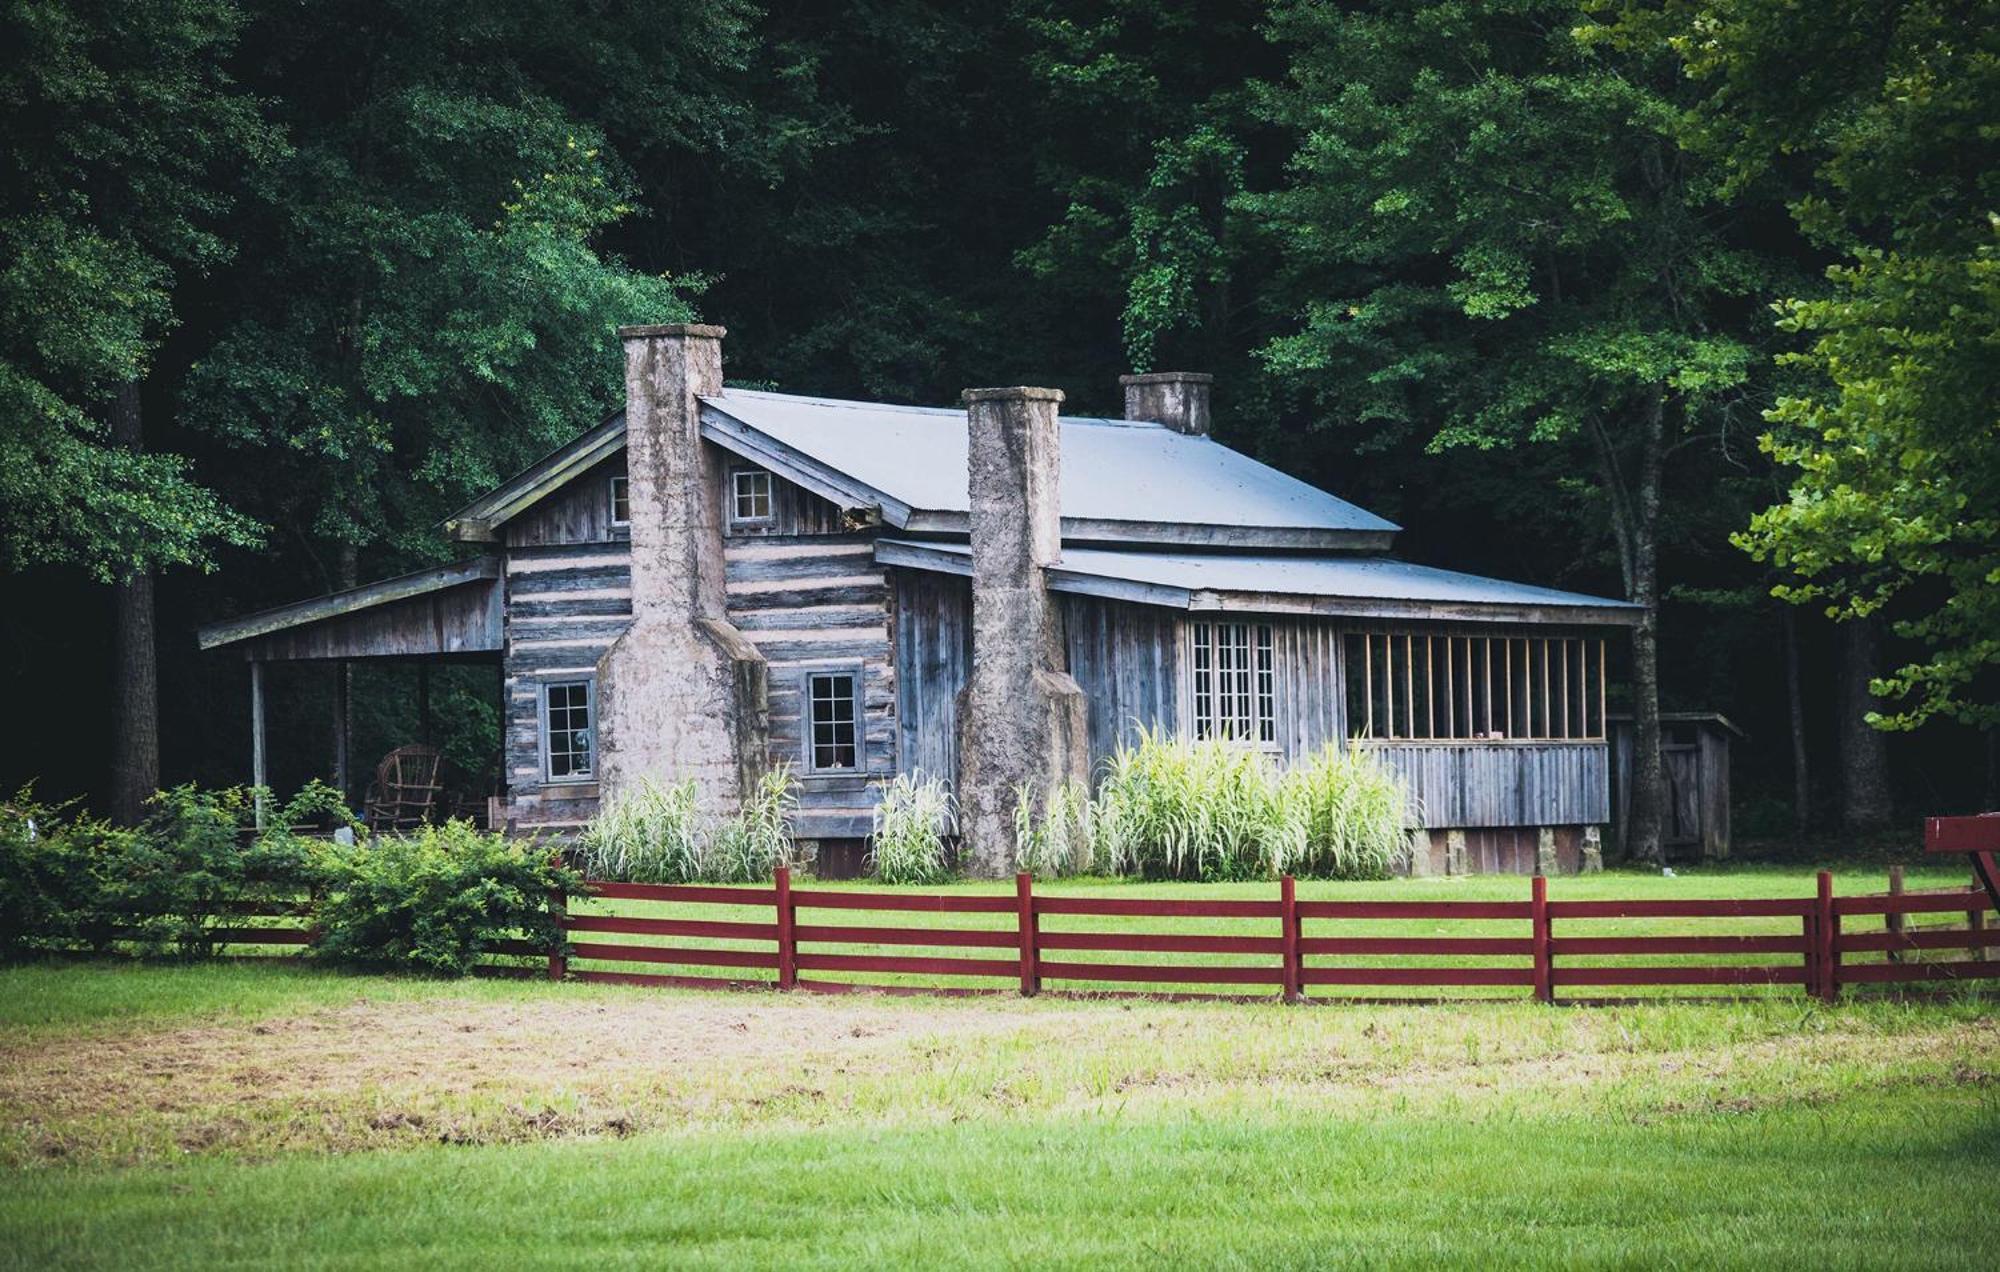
[1240,0,1770,860]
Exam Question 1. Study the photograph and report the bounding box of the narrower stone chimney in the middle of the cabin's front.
[958,388,1090,878]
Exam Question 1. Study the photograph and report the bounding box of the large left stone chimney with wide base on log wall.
[598,324,770,812]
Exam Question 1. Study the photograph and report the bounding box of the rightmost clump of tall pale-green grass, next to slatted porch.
[1282,744,1408,878]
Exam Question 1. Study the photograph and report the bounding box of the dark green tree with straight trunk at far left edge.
[0,0,276,822]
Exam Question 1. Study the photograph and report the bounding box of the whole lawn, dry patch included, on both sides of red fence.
[0,870,2000,1268]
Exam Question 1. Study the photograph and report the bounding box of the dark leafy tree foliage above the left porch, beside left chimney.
[184,0,746,584]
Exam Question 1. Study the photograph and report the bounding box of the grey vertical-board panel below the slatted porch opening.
[1362,742,1610,830]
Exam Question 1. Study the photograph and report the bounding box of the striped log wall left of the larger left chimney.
[502,540,632,830]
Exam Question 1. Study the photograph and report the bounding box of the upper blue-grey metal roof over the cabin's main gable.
[704,388,1398,534]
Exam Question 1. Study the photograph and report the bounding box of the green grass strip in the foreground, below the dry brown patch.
[0,1092,2000,1268]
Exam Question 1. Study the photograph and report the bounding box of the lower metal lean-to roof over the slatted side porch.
[876,540,1642,624]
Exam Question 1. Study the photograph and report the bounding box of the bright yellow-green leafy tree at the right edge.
[1660,0,2000,730]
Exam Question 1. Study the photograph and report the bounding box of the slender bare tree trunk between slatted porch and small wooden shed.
[1624,396,1666,864]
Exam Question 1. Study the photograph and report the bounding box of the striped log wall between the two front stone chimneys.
[722,520,896,838]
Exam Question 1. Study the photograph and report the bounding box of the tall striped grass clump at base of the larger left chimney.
[576,764,796,884]
